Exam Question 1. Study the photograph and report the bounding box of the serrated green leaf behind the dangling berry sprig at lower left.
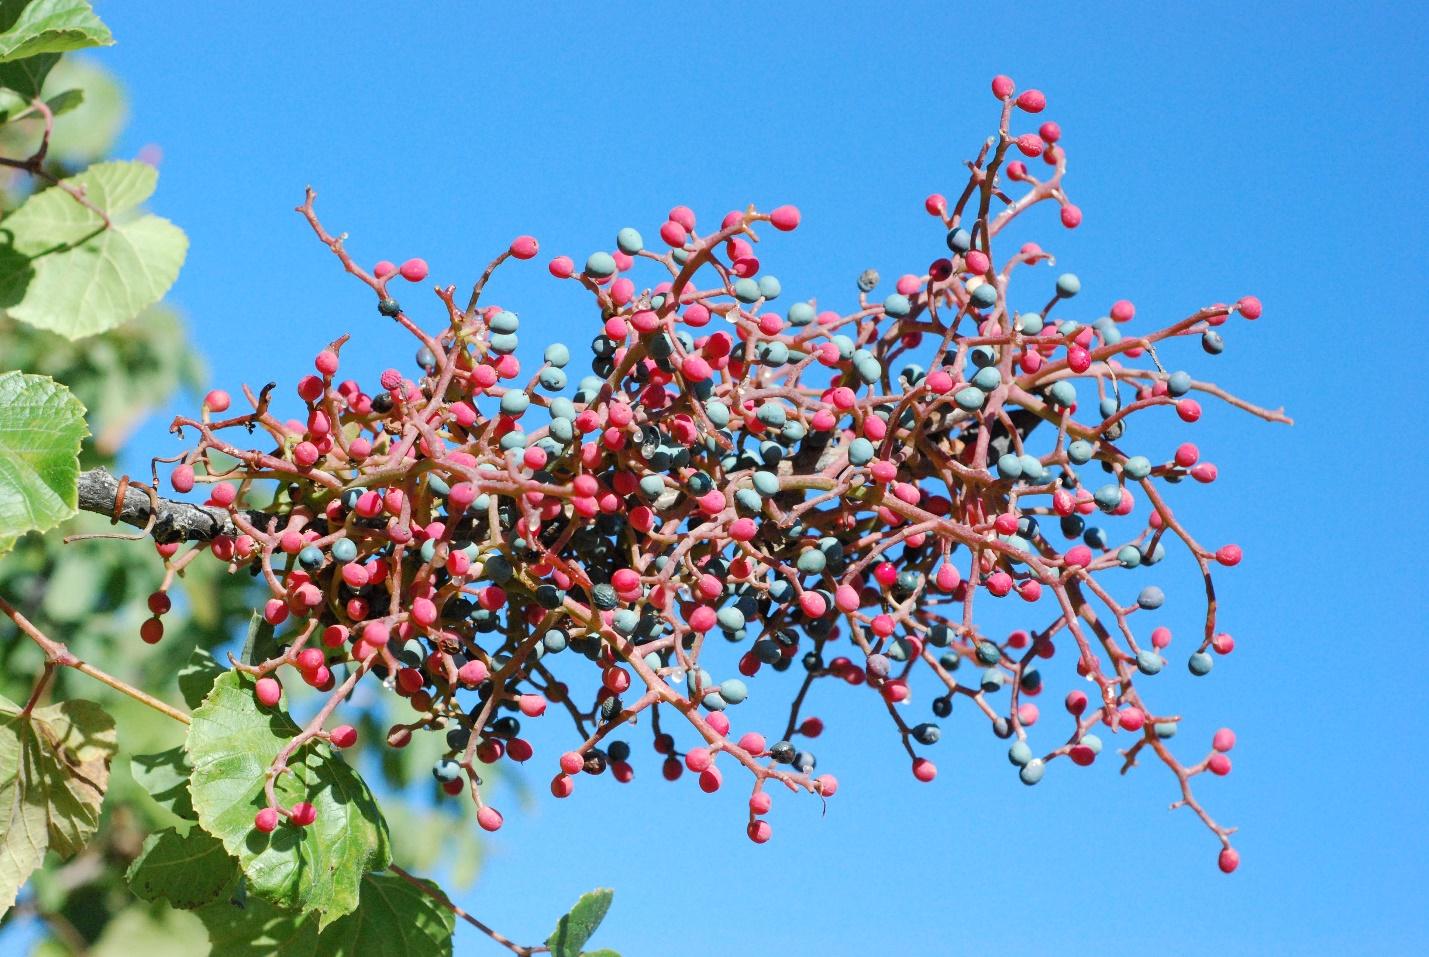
[184,671,392,930]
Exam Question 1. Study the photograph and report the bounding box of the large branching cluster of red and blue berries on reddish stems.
[144,77,1285,871]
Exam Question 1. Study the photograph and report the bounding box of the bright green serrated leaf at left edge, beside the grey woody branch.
[0,373,89,538]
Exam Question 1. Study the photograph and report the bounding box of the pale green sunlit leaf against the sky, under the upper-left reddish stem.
[0,161,189,339]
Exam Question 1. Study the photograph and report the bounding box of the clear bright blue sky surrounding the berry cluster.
[25,0,1429,957]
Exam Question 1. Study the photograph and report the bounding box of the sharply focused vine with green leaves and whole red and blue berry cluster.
[0,0,1289,957]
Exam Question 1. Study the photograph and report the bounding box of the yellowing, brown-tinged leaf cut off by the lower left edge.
[0,698,116,914]
